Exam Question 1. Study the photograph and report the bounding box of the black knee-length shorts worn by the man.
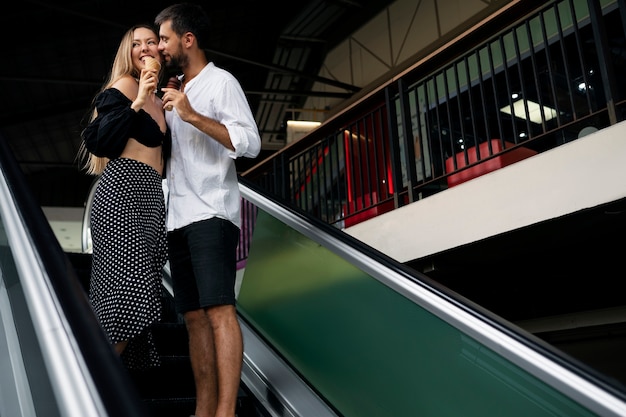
[167,217,239,313]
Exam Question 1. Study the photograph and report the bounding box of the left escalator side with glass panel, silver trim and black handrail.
[0,135,147,417]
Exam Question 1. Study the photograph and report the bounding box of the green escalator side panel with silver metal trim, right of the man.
[238,182,626,417]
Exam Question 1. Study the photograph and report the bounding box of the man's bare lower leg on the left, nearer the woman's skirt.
[185,309,217,417]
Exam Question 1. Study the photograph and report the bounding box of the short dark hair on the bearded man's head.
[154,3,211,49]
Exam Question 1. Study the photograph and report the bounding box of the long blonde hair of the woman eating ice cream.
[78,24,158,175]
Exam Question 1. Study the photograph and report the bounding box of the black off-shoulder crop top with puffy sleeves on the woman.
[82,88,171,159]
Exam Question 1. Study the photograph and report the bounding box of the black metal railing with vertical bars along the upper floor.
[243,0,626,227]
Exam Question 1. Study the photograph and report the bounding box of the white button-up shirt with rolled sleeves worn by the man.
[165,63,261,231]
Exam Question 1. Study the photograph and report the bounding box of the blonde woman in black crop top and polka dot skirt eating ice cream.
[81,25,171,368]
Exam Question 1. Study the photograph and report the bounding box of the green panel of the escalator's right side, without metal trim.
[238,210,595,417]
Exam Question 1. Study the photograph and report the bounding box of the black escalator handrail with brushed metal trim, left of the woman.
[0,136,147,417]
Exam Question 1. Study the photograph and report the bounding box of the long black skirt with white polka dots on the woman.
[89,158,167,369]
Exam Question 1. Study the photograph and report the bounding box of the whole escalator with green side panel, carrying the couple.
[0,129,626,417]
